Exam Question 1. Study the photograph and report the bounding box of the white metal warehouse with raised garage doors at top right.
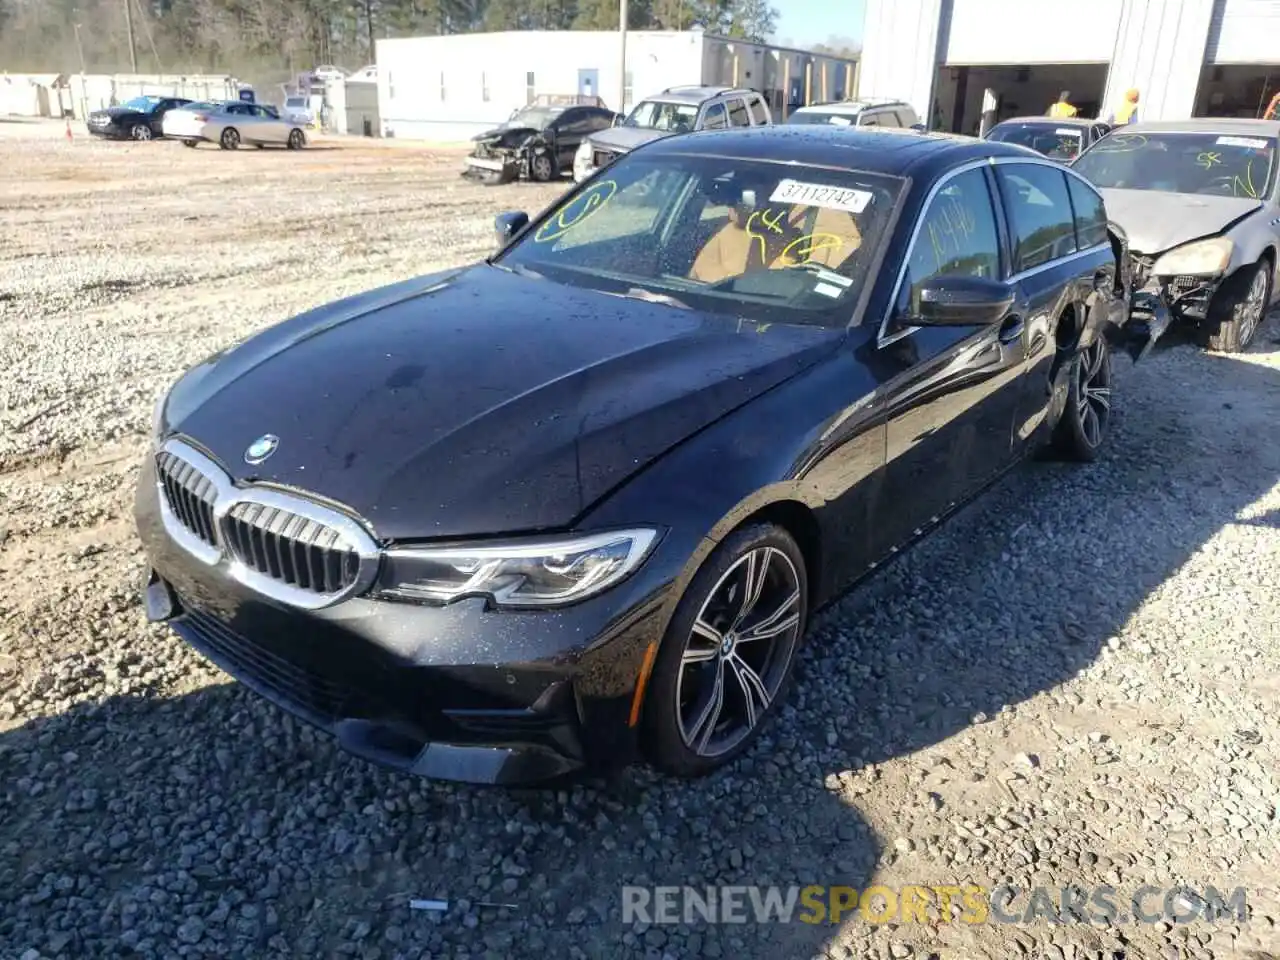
[860,0,1280,133]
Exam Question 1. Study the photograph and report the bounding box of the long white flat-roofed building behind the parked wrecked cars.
[378,31,856,141]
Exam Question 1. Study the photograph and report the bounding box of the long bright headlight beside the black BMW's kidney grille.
[376,529,658,608]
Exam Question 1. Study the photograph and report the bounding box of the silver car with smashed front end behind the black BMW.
[1073,119,1280,353]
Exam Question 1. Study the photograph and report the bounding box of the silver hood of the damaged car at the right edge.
[1100,187,1262,256]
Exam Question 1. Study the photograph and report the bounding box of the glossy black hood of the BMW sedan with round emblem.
[164,265,844,540]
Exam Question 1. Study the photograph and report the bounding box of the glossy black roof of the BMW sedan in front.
[644,124,1042,178]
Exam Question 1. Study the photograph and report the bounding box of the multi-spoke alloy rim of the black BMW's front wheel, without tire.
[676,547,801,758]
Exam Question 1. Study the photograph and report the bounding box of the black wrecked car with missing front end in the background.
[462,101,617,183]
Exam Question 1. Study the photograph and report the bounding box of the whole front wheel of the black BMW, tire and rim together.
[641,524,809,777]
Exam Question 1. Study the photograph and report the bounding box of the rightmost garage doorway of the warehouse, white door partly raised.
[1196,0,1280,118]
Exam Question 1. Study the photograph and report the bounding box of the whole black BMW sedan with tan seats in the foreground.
[137,127,1158,783]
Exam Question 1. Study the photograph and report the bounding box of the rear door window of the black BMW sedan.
[996,164,1076,273]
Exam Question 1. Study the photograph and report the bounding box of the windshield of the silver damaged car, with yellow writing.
[1073,133,1276,200]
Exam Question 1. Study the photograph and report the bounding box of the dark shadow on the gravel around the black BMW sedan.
[0,335,1280,960]
